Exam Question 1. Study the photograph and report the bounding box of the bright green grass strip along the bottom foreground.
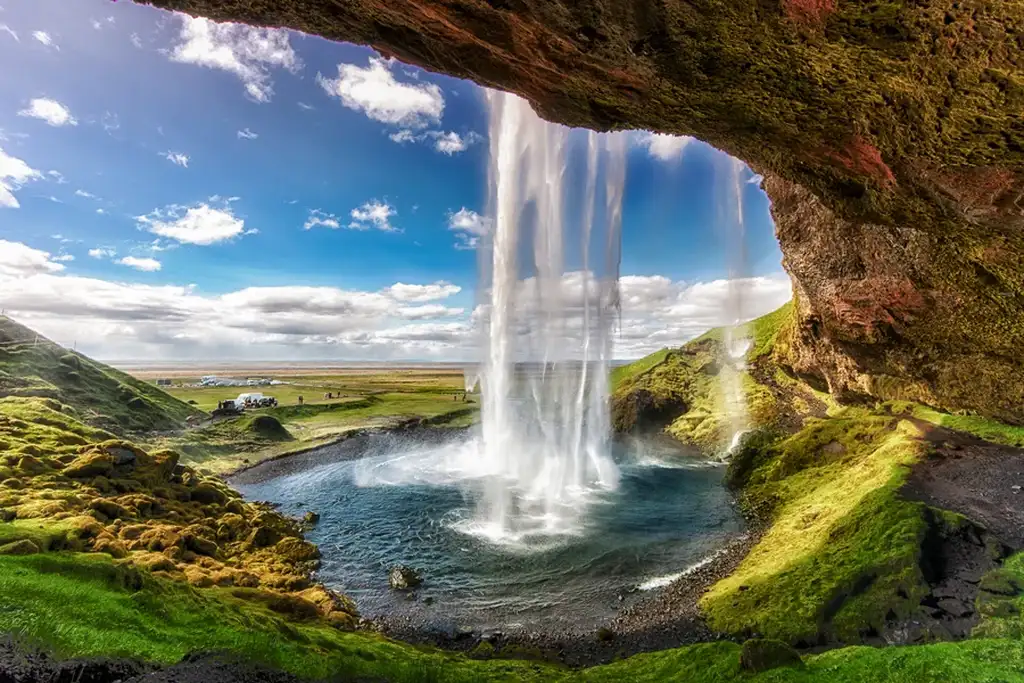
[0,553,1024,683]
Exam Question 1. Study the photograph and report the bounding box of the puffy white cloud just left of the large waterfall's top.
[316,57,444,128]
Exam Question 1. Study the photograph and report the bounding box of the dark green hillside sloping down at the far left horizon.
[0,316,201,433]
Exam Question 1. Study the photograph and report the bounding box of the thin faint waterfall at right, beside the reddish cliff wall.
[719,154,751,455]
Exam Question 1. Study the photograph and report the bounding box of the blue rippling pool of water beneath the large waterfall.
[236,434,743,629]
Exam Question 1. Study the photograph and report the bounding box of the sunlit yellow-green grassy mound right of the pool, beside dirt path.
[700,415,926,643]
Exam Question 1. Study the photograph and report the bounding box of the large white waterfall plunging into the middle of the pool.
[471,92,626,542]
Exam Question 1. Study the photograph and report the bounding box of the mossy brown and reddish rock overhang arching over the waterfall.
[147,0,1024,421]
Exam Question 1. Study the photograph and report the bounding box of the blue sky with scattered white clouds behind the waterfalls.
[0,0,788,359]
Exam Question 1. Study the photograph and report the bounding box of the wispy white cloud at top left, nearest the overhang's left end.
[170,14,302,102]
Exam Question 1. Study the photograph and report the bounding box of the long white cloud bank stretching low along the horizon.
[0,243,790,360]
